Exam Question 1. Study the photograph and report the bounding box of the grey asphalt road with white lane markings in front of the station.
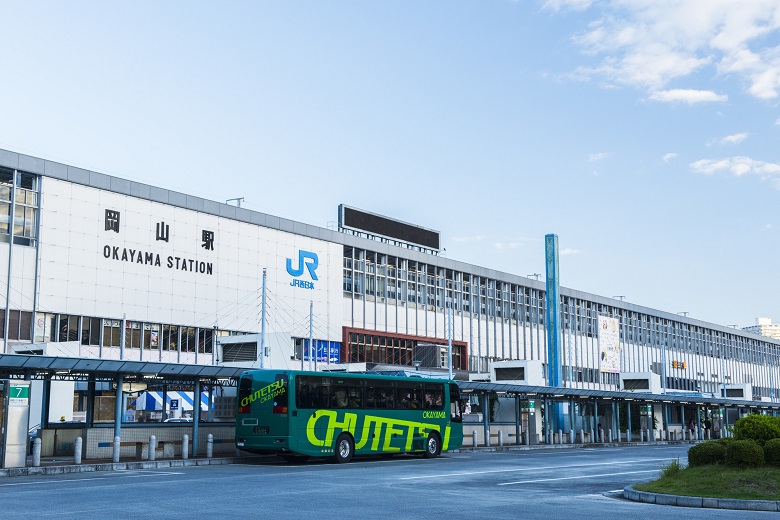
[0,446,772,520]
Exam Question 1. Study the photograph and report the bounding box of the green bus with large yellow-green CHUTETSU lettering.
[236,370,463,462]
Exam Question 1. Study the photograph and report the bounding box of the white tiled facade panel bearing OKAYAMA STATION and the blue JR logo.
[35,179,344,340]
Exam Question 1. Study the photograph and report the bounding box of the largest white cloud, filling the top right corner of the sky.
[560,0,780,102]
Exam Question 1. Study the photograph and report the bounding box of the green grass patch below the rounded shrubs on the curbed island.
[633,463,780,500]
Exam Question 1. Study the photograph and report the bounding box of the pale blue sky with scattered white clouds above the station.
[0,0,780,327]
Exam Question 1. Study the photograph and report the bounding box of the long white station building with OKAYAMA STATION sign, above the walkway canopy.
[0,150,780,442]
